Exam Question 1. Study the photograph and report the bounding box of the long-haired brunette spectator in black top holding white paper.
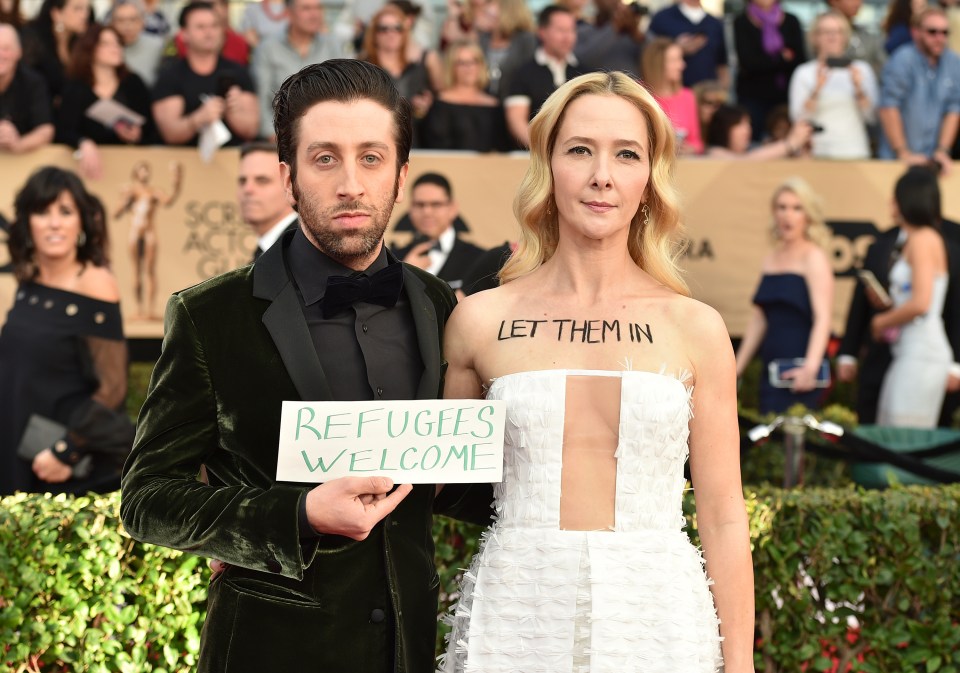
[57,23,159,179]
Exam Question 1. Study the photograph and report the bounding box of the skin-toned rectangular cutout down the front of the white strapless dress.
[560,375,622,530]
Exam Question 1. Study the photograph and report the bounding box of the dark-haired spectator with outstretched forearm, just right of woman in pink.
[707,104,813,161]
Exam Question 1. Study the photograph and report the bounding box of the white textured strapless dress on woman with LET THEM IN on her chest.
[441,370,723,673]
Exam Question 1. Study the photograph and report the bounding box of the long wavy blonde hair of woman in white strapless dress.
[500,72,690,296]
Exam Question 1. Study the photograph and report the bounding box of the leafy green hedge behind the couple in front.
[0,485,960,673]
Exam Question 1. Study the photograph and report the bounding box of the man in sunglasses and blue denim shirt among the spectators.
[879,7,960,172]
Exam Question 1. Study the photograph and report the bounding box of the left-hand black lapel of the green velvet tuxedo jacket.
[253,228,334,402]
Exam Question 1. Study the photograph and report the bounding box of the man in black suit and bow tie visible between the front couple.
[397,173,486,290]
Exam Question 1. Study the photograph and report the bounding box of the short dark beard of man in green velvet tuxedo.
[293,175,400,266]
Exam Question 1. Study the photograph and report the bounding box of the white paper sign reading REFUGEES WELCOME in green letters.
[277,400,506,484]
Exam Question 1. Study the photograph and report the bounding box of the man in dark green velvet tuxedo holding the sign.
[121,60,490,673]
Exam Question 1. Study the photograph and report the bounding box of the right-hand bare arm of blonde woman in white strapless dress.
[690,305,755,673]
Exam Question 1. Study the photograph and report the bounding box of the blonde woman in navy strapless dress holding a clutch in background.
[737,178,833,413]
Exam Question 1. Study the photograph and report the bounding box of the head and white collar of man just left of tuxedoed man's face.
[237,143,297,261]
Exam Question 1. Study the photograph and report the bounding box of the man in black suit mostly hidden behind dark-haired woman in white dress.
[837,167,960,426]
